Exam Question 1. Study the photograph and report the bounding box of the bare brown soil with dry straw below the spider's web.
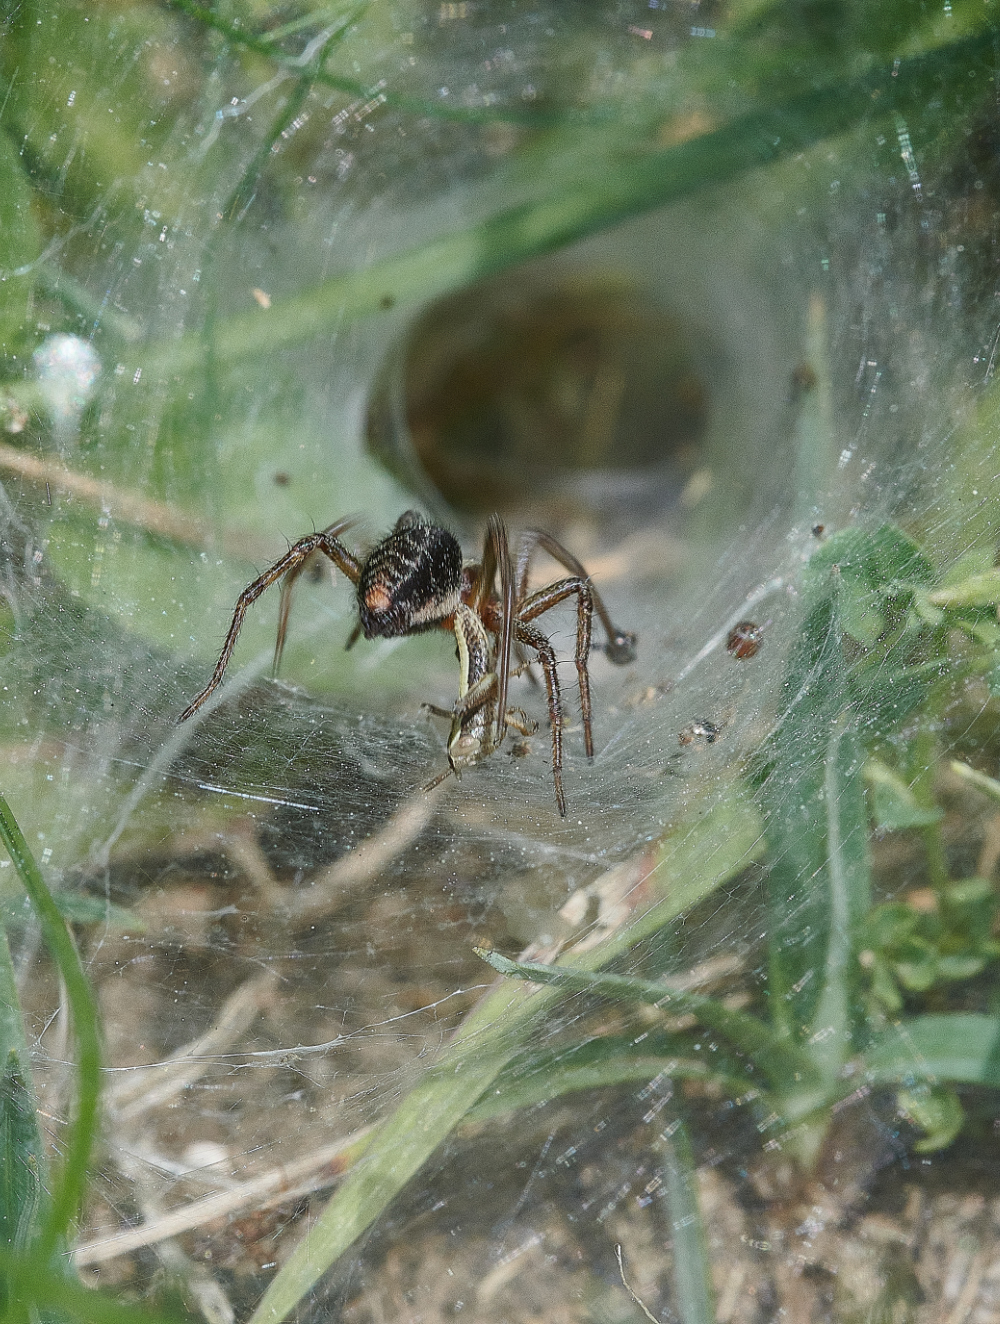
[19,714,1000,1324]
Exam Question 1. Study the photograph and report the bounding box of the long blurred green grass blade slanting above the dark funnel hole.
[150,28,993,377]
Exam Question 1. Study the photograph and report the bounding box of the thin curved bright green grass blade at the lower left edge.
[0,796,101,1260]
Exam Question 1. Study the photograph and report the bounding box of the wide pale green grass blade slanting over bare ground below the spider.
[250,797,760,1324]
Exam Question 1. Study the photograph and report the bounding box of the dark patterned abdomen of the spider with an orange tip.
[358,511,462,639]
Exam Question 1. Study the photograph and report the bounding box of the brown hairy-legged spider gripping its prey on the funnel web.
[179,510,636,817]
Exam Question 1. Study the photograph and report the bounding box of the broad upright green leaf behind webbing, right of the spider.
[755,524,940,1032]
